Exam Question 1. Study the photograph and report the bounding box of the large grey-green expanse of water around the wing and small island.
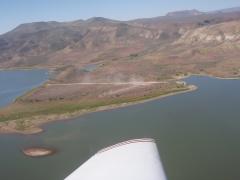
[0,73,240,180]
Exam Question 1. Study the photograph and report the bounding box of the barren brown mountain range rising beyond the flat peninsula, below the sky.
[0,7,240,81]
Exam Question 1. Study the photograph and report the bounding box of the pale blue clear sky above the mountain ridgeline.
[0,0,240,34]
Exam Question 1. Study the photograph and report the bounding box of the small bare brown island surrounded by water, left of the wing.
[23,147,56,157]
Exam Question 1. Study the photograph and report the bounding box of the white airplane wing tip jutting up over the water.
[65,139,166,180]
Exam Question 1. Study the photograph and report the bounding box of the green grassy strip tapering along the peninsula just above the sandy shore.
[0,87,188,122]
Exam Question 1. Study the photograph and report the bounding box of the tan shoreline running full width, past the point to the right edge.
[0,69,240,135]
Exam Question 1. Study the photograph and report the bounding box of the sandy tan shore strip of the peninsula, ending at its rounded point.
[0,85,198,135]
